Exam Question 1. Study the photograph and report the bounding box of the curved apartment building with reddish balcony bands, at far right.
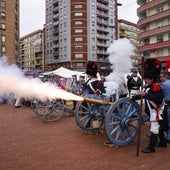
[137,0,170,67]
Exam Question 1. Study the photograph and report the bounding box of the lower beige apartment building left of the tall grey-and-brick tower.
[18,30,44,73]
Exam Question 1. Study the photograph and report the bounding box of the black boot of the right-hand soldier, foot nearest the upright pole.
[142,133,158,153]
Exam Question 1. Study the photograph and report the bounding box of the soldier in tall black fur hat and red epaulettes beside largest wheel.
[131,59,167,153]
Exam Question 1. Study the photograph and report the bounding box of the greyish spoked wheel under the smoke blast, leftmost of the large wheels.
[31,100,64,122]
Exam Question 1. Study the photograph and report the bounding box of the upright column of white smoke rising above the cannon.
[104,38,134,95]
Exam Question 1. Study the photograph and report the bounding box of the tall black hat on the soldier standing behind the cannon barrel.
[86,61,98,77]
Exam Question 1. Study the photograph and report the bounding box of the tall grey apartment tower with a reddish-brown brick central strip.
[45,0,116,74]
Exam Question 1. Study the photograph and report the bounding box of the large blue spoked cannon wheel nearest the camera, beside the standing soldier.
[105,98,140,146]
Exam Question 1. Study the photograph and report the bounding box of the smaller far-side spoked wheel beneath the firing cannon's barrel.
[75,102,104,131]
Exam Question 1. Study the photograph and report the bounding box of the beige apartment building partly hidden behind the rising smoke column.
[117,19,141,69]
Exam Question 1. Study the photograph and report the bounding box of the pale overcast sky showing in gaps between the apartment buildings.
[20,0,138,36]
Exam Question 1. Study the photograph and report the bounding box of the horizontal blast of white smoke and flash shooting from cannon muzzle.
[0,57,82,101]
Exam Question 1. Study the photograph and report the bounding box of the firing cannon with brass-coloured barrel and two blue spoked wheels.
[75,95,141,146]
